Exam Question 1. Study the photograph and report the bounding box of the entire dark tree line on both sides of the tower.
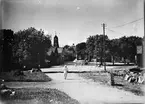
[0,27,142,71]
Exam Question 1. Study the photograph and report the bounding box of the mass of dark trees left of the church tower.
[0,27,52,71]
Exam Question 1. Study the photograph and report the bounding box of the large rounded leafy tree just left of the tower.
[13,27,51,67]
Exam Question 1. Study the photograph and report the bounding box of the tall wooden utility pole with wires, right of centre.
[102,23,106,71]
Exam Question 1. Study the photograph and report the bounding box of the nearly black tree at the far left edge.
[0,29,14,71]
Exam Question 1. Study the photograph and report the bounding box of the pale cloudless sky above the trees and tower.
[0,0,144,46]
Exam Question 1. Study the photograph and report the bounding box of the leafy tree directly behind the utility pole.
[86,35,109,65]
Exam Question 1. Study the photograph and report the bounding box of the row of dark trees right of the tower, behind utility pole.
[76,35,142,65]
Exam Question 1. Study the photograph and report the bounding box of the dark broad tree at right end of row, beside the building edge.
[110,36,142,63]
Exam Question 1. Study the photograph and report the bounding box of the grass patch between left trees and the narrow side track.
[0,71,51,82]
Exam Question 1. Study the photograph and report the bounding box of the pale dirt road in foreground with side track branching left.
[4,73,145,104]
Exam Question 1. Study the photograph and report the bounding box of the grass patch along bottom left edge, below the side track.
[1,88,79,104]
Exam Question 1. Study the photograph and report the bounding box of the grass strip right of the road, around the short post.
[79,72,144,96]
